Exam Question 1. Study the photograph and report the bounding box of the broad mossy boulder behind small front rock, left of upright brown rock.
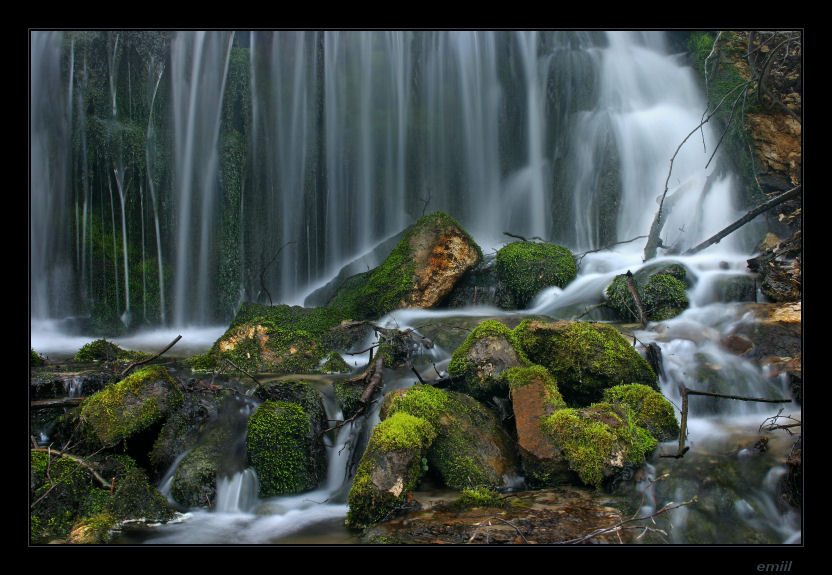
[385,385,517,489]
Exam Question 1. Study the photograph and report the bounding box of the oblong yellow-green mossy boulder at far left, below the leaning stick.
[81,366,183,446]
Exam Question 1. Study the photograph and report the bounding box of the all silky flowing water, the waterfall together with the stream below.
[30,31,801,544]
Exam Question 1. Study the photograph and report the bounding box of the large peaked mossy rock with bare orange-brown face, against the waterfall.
[327,212,482,320]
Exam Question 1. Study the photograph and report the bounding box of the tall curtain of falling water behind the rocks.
[31,31,748,326]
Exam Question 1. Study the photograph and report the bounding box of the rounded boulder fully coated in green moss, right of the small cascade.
[246,400,326,497]
